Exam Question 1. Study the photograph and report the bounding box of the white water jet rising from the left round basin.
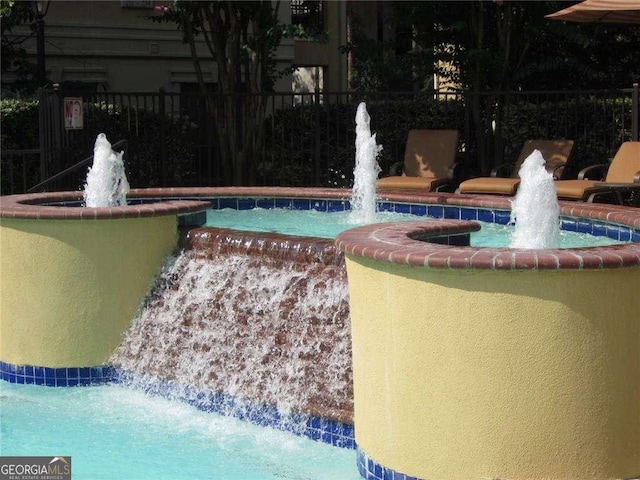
[84,133,129,207]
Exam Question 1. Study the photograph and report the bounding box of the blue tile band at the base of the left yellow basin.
[0,361,117,387]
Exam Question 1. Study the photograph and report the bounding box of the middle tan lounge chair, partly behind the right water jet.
[456,140,573,195]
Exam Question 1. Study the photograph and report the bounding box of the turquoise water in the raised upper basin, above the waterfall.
[205,208,622,248]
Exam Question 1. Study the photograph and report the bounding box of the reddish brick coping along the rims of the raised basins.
[0,187,640,270]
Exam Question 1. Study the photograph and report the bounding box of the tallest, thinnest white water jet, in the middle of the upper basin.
[349,102,382,223]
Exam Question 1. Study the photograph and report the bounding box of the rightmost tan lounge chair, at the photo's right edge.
[555,142,640,205]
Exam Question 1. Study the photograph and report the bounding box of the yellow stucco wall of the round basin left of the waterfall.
[0,216,177,367]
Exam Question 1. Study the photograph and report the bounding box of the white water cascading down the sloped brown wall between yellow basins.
[111,250,352,422]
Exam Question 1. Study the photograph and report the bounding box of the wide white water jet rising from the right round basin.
[509,150,560,248]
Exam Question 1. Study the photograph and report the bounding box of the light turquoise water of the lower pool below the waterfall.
[0,381,361,480]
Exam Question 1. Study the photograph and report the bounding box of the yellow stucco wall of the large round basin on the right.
[347,255,640,480]
